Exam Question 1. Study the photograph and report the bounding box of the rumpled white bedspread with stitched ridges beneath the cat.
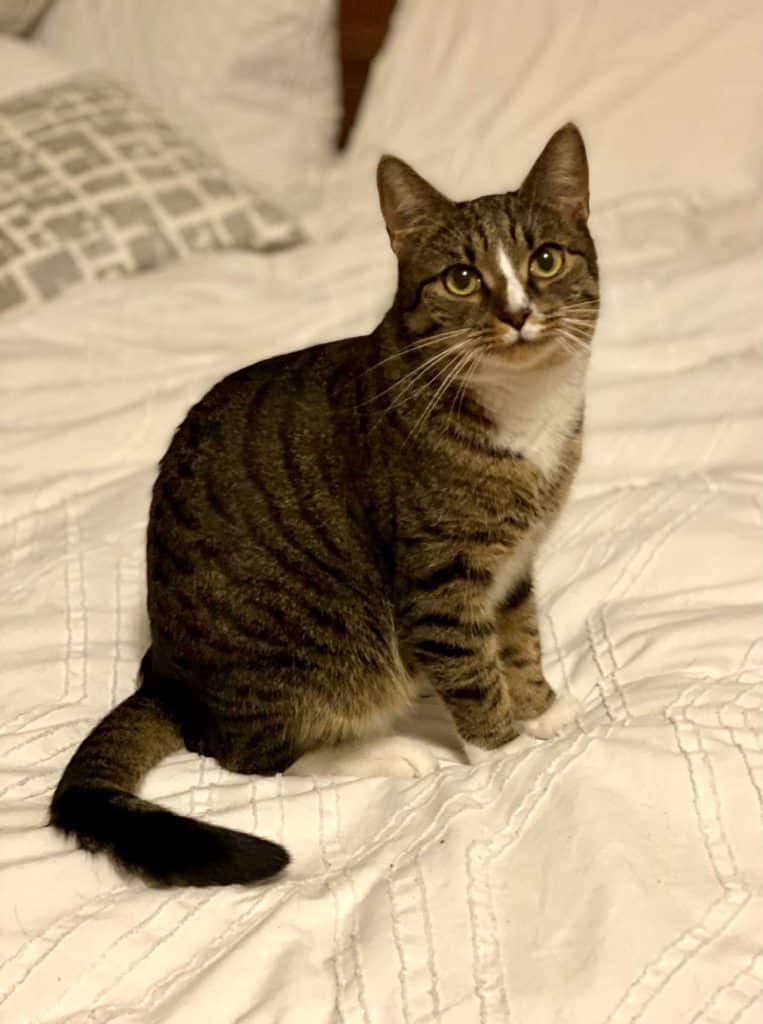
[0,169,763,1024]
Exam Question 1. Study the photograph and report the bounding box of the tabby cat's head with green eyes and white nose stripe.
[378,124,598,370]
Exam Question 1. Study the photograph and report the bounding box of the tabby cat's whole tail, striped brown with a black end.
[50,659,289,886]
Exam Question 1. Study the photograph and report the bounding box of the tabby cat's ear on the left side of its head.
[376,157,451,256]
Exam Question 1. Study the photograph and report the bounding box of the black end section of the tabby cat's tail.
[50,788,289,886]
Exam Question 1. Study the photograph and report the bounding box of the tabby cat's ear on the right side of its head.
[519,124,588,222]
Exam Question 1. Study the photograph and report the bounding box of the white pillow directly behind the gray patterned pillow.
[35,0,340,213]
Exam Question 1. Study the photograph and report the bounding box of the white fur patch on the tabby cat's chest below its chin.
[476,359,586,478]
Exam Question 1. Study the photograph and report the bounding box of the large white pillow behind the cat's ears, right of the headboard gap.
[349,0,763,207]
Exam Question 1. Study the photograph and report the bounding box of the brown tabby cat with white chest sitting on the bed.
[51,125,599,886]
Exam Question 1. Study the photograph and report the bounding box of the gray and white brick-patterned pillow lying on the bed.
[0,74,299,311]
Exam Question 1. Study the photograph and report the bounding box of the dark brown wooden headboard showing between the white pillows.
[337,0,394,148]
